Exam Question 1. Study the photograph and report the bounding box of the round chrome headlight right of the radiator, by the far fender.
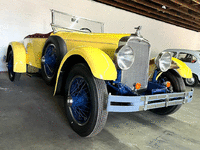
[155,52,172,72]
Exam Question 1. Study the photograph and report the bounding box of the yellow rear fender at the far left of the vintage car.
[6,42,26,73]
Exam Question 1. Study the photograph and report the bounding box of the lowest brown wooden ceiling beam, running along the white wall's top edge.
[95,0,200,32]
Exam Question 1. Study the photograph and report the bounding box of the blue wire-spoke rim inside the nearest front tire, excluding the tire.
[67,76,91,126]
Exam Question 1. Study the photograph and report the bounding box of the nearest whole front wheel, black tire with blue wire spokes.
[64,63,108,137]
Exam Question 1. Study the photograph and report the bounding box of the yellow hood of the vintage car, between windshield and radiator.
[51,32,130,59]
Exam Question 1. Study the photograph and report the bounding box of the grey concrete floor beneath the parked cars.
[0,73,200,150]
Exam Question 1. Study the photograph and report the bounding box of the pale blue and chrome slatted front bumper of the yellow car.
[107,89,194,112]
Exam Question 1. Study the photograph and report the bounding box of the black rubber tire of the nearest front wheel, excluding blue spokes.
[64,63,108,137]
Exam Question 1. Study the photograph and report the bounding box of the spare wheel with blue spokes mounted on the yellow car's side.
[41,36,67,84]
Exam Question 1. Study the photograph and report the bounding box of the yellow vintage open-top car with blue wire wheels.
[6,10,193,137]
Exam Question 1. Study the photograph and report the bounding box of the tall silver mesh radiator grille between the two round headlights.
[121,39,150,89]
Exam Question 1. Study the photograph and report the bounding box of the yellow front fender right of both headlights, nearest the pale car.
[172,57,192,78]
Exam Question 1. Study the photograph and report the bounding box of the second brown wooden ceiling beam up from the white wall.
[114,0,200,28]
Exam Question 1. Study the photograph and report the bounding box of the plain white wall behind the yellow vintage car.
[0,0,200,71]
